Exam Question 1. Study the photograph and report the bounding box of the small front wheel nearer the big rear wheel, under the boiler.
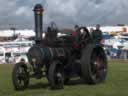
[48,61,64,89]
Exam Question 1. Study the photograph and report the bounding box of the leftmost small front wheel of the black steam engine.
[12,62,29,90]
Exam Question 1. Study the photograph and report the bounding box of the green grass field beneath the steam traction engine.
[0,61,128,96]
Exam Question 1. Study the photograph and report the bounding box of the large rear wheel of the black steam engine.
[81,44,107,84]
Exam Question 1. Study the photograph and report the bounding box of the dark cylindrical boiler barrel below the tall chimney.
[28,46,66,66]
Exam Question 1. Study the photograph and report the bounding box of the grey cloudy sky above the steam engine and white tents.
[0,0,128,29]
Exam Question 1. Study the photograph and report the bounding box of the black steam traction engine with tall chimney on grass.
[12,4,107,90]
